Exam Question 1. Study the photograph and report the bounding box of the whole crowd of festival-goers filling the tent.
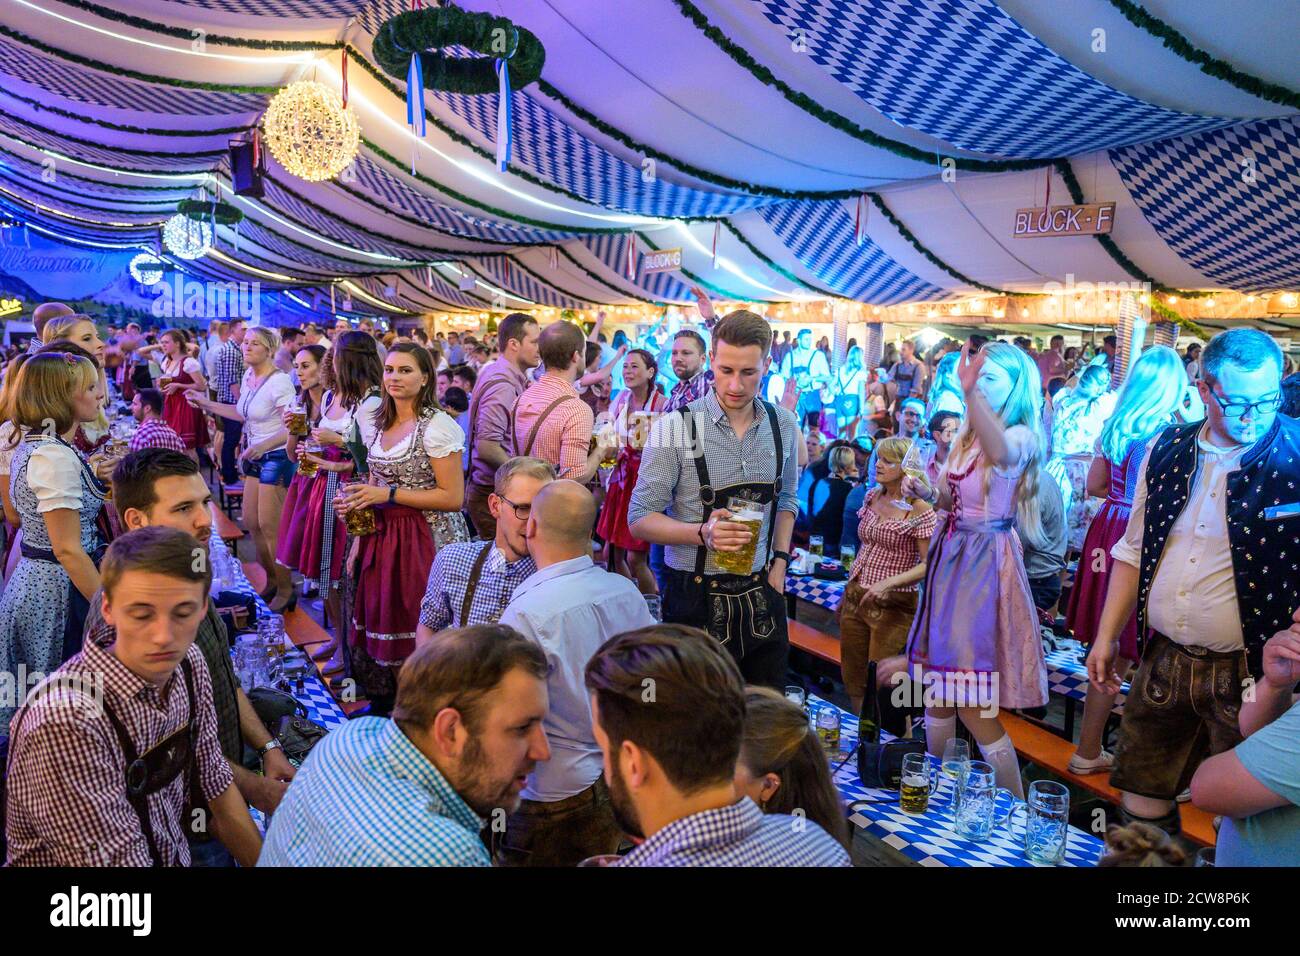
[0,294,1300,866]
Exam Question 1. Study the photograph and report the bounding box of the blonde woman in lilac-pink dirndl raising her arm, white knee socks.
[902,342,1050,796]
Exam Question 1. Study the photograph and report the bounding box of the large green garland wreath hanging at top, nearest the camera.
[373,5,546,94]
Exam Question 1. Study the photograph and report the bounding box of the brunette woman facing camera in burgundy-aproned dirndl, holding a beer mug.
[335,342,469,715]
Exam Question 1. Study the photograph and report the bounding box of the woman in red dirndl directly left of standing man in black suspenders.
[595,349,668,594]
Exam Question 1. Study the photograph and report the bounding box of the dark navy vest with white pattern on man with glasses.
[1138,414,1300,678]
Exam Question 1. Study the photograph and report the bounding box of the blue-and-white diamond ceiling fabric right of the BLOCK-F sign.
[1110,117,1300,293]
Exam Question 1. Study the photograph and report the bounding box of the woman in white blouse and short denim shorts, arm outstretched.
[186,328,298,614]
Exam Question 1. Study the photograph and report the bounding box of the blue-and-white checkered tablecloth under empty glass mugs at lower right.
[809,695,1105,866]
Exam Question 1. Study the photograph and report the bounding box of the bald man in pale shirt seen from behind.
[493,480,655,866]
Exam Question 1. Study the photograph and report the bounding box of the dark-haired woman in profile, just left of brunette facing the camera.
[293,332,384,680]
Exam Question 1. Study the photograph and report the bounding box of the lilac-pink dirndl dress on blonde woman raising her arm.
[907,444,1048,709]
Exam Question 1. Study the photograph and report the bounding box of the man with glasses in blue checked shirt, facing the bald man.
[415,457,555,646]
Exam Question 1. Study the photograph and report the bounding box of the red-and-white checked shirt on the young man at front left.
[5,635,234,866]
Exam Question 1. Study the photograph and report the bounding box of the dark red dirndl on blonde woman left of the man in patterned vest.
[1065,442,1144,661]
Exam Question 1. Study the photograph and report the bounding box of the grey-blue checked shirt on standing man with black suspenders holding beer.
[628,389,803,574]
